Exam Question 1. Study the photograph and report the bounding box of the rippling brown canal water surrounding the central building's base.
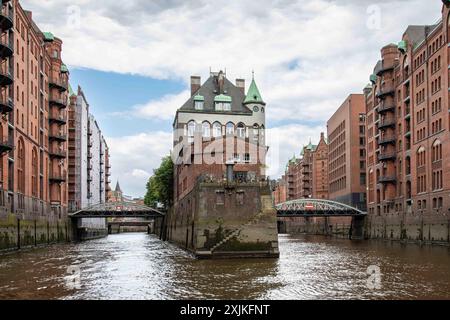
[0,233,450,300]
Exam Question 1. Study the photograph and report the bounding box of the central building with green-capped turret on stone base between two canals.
[160,71,279,258]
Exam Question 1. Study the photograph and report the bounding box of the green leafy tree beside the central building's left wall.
[144,156,174,208]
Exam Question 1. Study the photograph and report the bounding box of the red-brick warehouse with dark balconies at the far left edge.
[0,0,69,248]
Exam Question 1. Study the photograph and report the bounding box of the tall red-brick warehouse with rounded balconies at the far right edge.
[366,1,450,242]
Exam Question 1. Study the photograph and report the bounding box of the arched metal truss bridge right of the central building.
[275,199,367,218]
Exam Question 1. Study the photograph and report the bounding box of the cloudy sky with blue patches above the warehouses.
[21,0,442,196]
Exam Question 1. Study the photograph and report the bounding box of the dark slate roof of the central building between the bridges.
[178,75,252,115]
